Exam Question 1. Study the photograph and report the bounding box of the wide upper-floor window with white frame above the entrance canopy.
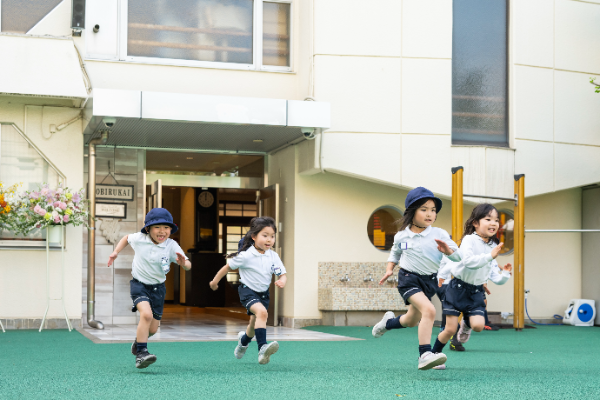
[122,0,291,71]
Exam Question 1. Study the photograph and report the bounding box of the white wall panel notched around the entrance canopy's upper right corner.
[315,56,401,133]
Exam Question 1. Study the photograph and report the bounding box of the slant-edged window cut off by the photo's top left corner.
[0,0,62,33]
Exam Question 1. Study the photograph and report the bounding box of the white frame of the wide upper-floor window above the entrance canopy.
[112,0,294,73]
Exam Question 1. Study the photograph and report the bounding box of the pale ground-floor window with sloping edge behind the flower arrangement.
[0,124,64,246]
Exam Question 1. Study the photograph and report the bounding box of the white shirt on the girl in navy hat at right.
[388,226,461,275]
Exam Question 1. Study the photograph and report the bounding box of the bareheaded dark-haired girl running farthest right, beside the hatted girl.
[433,203,512,364]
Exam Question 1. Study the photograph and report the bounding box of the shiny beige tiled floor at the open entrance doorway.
[79,309,362,343]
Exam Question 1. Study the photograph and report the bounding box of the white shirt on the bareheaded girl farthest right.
[438,233,510,285]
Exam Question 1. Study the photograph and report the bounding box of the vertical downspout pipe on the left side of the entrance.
[87,131,108,329]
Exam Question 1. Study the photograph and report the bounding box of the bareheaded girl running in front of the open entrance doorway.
[210,217,287,364]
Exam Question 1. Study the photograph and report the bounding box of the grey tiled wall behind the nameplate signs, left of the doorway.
[82,147,146,324]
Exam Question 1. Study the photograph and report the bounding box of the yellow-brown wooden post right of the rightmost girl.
[513,174,525,331]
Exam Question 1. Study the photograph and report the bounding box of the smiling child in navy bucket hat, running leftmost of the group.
[108,208,192,368]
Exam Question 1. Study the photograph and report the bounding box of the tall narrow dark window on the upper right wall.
[452,0,508,147]
